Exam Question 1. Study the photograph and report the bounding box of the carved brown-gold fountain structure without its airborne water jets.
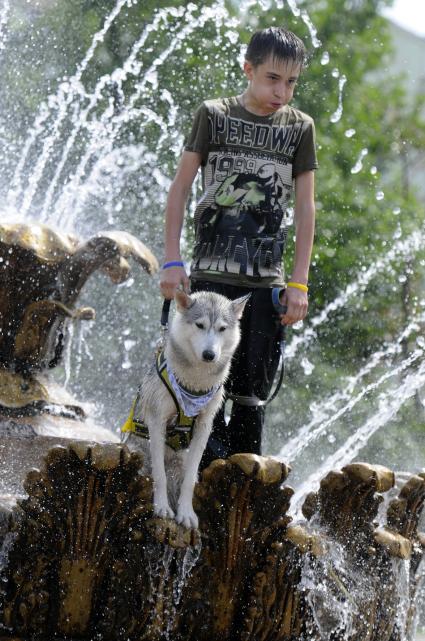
[0,223,425,641]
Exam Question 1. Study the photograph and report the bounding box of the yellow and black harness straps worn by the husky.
[121,350,203,451]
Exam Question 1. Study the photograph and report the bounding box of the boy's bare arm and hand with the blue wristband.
[160,151,202,299]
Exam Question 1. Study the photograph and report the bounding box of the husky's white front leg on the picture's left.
[146,416,174,519]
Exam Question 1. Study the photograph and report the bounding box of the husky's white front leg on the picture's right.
[176,414,212,528]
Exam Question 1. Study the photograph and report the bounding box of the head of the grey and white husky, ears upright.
[170,290,250,363]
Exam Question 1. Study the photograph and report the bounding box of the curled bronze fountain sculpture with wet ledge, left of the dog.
[0,223,158,494]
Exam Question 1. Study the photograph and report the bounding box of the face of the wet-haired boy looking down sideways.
[244,57,301,115]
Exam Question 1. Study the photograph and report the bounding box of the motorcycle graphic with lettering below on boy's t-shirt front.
[194,156,290,276]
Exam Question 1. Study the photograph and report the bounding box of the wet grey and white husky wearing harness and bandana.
[123,290,249,528]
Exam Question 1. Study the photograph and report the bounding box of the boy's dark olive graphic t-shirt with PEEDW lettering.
[185,97,317,286]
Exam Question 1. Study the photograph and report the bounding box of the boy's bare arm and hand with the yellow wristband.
[281,171,315,325]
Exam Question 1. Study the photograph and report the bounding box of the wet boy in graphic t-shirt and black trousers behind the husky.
[161,27,317,466]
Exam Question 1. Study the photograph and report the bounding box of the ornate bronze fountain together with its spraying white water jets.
[0,0,425,641]
